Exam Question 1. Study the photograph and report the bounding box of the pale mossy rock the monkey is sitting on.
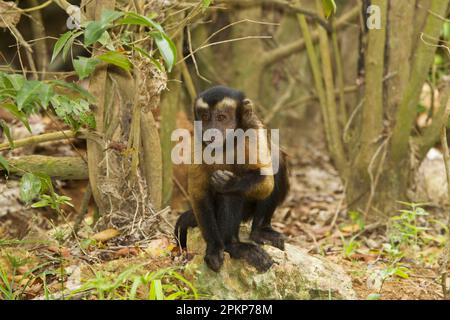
[185,229,356,300]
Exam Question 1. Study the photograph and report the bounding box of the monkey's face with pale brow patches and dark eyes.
[194,97,239,143]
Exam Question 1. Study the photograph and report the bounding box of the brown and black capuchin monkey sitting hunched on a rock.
[175,86,289,272]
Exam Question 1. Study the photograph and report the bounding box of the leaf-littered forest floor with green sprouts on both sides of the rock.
[0,114,446,299]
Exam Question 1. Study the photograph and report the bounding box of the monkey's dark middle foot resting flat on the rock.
[225,242,274,272]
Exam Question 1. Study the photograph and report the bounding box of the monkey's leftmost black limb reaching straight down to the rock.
[193,194,224,272]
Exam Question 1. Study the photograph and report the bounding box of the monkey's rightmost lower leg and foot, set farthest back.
[250,195,284,250]
